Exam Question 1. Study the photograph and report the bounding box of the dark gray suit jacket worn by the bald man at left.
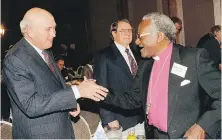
[3,38,77,139]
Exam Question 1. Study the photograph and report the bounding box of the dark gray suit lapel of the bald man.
[23,38,59,86]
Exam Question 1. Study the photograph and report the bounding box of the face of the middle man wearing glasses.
[112,22,132,47]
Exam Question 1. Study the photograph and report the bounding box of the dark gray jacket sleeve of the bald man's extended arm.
[3,55,77,117]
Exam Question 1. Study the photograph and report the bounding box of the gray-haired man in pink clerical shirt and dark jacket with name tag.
[105,13,221,139]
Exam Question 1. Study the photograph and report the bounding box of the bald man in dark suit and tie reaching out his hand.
[3,8,106,139]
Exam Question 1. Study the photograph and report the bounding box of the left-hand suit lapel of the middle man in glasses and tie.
[111,44,133,79]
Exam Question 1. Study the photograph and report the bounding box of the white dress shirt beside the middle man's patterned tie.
[114,42,137,73]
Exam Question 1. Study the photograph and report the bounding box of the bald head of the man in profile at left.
[20,8,56,50]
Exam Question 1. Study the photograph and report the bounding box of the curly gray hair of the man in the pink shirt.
[142,12,176,41]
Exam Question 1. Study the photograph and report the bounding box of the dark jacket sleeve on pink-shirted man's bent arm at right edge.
[196,49,221,138]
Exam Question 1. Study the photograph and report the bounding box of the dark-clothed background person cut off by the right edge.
[197,25,221,69]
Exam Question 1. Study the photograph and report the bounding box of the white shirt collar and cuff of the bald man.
[25,38,81,100]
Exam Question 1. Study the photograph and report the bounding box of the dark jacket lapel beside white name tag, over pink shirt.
[168,46,181,129]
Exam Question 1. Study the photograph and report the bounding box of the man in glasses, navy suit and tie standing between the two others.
[93,19,143,138]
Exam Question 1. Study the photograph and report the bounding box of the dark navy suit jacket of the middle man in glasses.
[93,43,142,130]
